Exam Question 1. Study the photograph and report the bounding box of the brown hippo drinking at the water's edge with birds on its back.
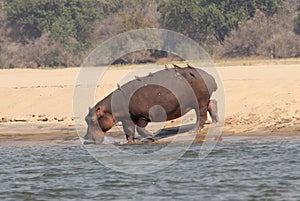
[84,64,218,144]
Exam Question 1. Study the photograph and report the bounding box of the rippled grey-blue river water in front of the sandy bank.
[0,139,300,200]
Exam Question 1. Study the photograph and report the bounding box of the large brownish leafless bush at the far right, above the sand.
[218,11,300,58]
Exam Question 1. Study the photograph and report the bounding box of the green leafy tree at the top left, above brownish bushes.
[5,0,103,45]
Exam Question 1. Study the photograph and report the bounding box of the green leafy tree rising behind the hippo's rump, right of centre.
[159,0,283,42]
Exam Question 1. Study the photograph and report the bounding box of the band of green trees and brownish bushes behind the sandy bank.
[0,0,300,68]
